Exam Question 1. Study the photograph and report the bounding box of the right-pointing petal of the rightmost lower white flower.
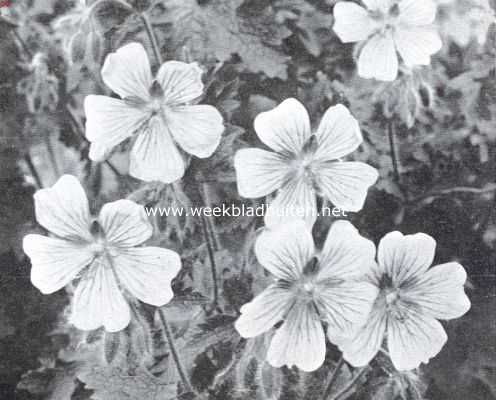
[401,262,470,319]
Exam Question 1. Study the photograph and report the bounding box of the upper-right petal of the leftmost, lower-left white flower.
[98,200,153,247]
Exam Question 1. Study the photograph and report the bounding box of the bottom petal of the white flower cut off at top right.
[358,32,398,81]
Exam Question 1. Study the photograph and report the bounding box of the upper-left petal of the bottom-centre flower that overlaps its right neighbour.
[255,220,315,281]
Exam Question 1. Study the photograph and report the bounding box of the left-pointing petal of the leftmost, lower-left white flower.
[22,235,94,294]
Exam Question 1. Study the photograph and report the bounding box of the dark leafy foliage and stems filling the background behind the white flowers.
[0,0,496,400]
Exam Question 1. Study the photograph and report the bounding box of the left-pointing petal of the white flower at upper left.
[84,95,150,161]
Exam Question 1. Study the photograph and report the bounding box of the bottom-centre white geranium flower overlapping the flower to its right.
[235,220,378,371]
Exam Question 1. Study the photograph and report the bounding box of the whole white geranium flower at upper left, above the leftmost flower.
[84,43,224,183]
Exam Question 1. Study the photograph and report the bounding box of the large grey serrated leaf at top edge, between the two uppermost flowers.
[155,0,291,79]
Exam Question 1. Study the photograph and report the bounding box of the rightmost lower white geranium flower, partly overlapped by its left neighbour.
[338,232,470,370]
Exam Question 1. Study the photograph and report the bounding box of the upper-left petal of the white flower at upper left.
[102,43,152,100]
